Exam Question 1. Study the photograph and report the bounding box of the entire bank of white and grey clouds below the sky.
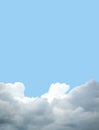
[0,80,99,130]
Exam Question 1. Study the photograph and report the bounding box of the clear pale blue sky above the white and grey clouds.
[0,0,99,96]
